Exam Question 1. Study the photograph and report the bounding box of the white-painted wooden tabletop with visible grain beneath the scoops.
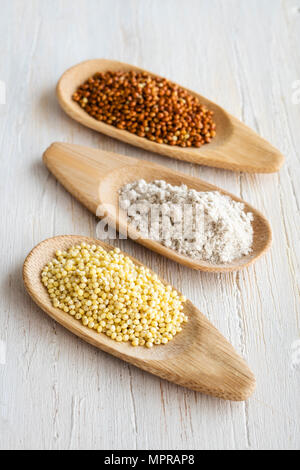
[0,0,300,449]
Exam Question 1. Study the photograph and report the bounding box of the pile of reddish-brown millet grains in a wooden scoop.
[73,71,216,147]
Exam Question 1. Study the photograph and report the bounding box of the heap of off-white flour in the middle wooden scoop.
[119,180,253,263]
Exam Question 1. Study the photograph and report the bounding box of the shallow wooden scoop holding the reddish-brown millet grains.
[57,59,284,173]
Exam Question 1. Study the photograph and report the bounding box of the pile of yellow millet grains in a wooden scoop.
[41,243,188,348]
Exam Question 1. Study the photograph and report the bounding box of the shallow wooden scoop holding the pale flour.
[43,143,272,272]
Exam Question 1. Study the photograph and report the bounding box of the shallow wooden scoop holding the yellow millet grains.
[23,235,255,401]
